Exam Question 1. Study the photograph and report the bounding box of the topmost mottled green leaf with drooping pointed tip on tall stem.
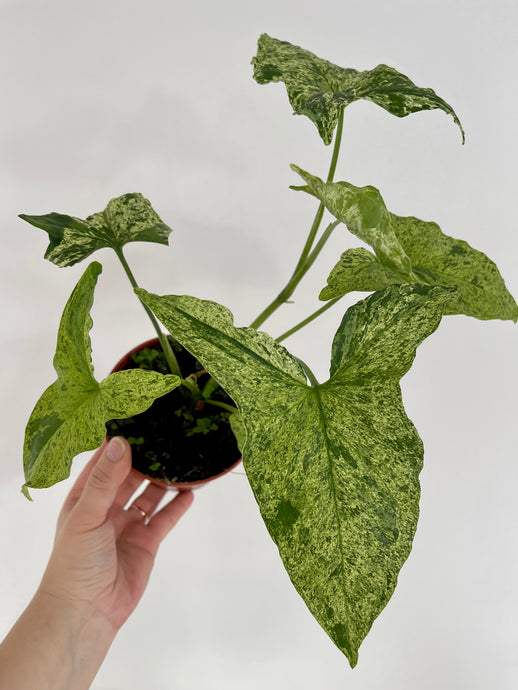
[252,34,464,144]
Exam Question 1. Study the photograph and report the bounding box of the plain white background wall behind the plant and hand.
[0,0,518,690]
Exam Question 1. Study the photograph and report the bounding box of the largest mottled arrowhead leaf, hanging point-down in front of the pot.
[137,285,456,666]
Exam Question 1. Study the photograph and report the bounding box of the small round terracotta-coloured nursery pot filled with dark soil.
[106,338,241,491]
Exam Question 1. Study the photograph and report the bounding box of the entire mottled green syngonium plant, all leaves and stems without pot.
[21,34,518,666]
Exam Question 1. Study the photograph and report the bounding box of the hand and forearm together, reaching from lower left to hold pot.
[0,438,193,690]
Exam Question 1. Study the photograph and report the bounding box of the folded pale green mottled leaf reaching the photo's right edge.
[292,165,518,321]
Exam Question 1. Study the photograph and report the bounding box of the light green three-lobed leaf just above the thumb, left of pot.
[22,262,180,498]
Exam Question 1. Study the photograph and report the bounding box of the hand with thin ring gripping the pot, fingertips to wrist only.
[38,437,193,630]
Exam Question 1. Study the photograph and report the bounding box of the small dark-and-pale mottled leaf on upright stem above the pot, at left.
[20,194,171,266]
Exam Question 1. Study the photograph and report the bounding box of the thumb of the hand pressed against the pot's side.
[73,436,131,529]
